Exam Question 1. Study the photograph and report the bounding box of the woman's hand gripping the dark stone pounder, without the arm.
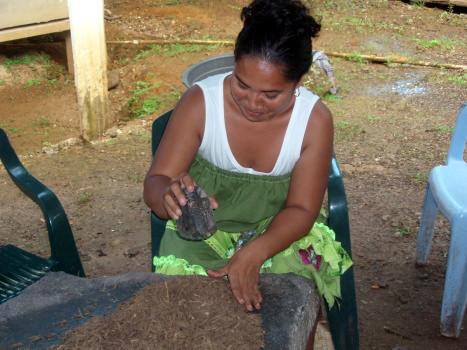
[162,173,218,220]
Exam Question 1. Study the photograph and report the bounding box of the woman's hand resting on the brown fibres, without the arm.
[207,248,263,311]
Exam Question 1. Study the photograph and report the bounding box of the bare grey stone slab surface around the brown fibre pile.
[0,272,320,350]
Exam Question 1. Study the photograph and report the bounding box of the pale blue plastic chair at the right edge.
[416,102,467,338]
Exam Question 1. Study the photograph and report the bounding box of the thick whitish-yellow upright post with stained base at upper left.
[68,0,110,141]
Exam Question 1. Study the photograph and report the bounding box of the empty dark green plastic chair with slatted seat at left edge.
[0,128,85,304]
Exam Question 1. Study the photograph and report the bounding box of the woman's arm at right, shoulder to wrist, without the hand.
[252,101,334,254]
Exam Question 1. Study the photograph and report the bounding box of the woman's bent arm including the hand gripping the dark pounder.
[144,85,205,219]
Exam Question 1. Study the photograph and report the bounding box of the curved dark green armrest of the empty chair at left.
[0,128,85,277]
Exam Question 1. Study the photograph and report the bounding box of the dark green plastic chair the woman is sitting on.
[151,110,360,350]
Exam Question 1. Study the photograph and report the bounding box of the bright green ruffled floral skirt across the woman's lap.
[154,209,352,307]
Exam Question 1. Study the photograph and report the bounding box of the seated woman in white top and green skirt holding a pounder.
[144,0,350,311]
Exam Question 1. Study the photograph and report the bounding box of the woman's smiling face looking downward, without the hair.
[230,56,300,122]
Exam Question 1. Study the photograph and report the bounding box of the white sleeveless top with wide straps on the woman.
[196,72,319,176]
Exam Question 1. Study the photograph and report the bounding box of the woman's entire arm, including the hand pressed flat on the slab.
[209,101,334,311]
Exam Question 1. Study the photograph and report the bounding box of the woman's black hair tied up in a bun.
[234,0,321,82]
